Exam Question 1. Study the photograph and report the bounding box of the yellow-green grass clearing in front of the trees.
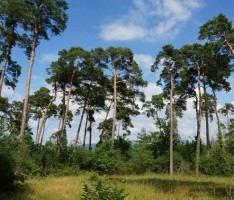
[0,174,234,200]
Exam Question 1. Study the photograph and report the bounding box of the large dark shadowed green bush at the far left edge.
[0,134,35,190]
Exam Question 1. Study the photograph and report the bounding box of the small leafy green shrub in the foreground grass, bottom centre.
[81,180,127,200]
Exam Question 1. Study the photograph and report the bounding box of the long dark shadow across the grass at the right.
[110,177,234,199]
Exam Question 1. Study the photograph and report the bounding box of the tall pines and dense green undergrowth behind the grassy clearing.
[0,0,234,194]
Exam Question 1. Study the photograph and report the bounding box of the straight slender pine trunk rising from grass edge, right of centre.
[169,75,174,175]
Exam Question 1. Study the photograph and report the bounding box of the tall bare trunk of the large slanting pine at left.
[20,31,38,138]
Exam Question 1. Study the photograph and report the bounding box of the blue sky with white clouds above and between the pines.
[4,0,234,144]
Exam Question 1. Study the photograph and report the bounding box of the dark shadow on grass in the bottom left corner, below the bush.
[0,183,34,200]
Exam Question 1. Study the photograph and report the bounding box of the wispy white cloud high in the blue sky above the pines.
[100,0,202,41]
